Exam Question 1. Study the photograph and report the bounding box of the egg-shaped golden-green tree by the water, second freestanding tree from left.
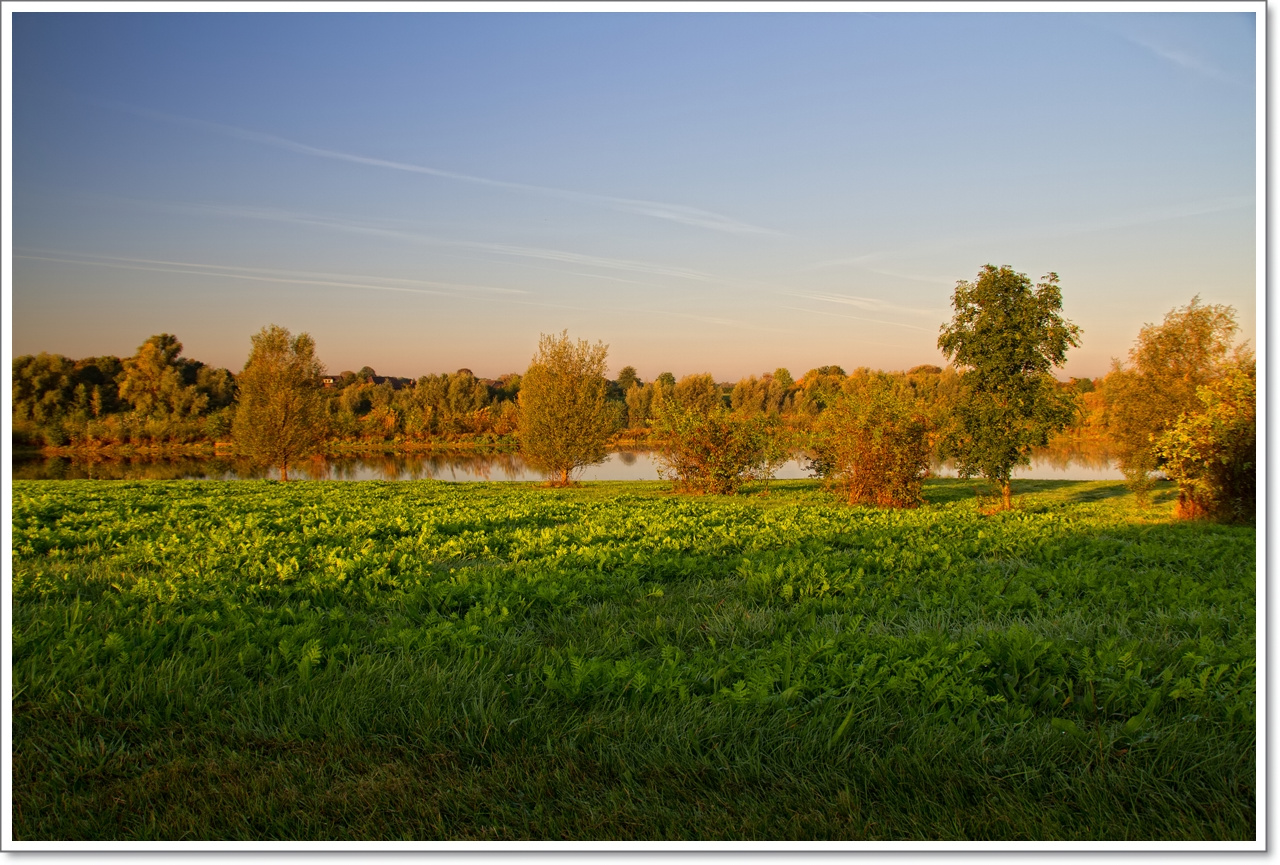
[516,330,620,486]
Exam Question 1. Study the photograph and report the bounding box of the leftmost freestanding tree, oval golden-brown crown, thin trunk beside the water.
[232,325,328,481]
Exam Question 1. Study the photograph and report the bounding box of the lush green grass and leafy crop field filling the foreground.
[13,480,1258,839]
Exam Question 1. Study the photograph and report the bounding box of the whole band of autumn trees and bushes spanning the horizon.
[13,265,1256,520]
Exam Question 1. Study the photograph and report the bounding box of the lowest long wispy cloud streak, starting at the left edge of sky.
[13,252,526,296]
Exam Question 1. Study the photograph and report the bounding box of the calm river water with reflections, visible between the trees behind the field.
[13,447,1121,481]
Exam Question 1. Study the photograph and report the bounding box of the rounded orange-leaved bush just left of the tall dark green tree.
[809,374,929,508]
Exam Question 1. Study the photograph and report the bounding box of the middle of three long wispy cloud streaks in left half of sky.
[141,201,718,283]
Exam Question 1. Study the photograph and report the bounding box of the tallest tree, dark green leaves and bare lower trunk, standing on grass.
[938,265,1080,509]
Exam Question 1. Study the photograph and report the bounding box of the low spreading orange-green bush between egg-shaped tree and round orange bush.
[654,386,788,495]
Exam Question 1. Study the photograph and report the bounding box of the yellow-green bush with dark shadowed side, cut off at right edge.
[1156,354,1257,522]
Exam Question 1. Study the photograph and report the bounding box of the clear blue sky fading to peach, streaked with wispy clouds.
[5,4,1261,381]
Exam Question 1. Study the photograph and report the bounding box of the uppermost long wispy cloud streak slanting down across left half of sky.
[106,102,782,235]
